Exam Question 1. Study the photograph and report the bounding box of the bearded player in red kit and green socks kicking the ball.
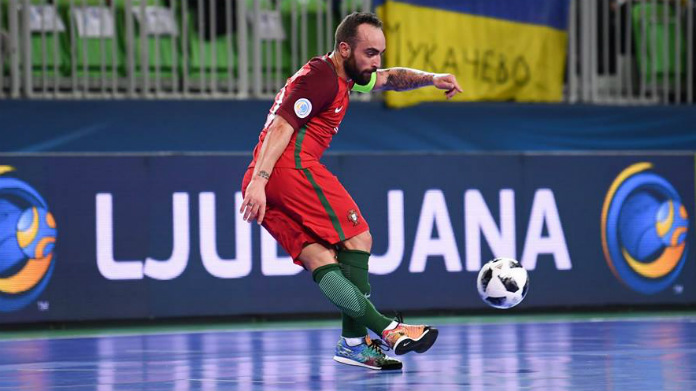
[240,12,462,370]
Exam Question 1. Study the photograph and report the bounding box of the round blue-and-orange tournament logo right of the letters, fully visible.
[602,163,689,294]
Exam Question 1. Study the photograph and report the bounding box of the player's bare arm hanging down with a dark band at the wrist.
[239,116,295,224]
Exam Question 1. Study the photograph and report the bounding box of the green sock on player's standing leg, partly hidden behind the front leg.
[337,250,370,338]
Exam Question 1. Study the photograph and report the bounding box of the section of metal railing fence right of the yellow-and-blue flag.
[566,0,696,105]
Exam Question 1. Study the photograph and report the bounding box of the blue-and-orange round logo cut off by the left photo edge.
[0,166,57,312]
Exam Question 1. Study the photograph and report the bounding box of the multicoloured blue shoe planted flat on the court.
[334,336,403,370]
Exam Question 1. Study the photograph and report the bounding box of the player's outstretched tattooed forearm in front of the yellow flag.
[374,68,462,99]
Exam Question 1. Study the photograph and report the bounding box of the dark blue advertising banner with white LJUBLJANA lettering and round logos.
[0,154,696,323]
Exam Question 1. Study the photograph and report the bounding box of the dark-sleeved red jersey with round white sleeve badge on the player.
[249,55,354,169]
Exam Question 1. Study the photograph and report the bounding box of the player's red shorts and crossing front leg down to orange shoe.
[264,166,437,354]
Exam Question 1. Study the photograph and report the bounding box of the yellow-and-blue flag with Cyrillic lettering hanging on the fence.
[377,0,570,107]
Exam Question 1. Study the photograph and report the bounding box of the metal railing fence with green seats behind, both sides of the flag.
[0,0,696,104]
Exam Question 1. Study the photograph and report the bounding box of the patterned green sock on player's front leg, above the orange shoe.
[312,263,392,335]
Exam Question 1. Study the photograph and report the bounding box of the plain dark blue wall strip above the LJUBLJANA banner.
[0,100,696,152]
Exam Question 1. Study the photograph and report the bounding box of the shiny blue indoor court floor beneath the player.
[0,313,696,391]
